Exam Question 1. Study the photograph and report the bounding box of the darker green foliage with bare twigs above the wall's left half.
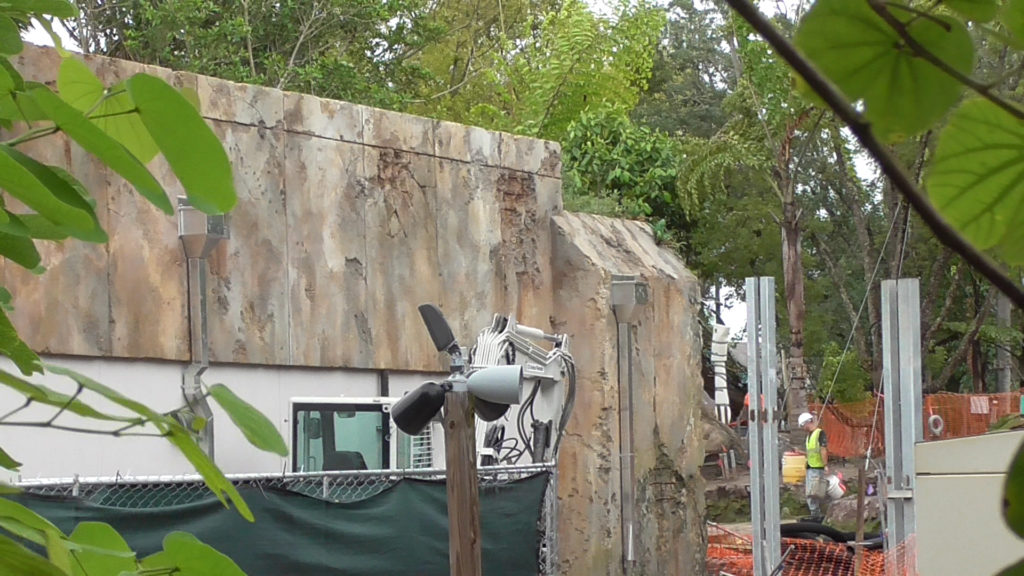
[69,0,444,109]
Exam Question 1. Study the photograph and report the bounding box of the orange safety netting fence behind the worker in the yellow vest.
[810,392,1021,458]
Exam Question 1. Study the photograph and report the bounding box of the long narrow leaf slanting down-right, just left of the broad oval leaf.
[23,88,174,214]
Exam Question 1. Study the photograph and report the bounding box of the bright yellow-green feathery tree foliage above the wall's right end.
[423,0,665,140]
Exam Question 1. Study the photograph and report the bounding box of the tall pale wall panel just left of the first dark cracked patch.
[285,134,374,367]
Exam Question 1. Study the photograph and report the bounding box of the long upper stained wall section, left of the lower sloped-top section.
[4,43,561,370]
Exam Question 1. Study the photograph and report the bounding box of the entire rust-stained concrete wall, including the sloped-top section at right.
[8,48,706,575]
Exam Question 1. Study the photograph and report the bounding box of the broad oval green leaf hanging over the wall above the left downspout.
[127,74,238,213]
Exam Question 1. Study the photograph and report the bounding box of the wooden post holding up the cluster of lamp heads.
[444,390,481,576]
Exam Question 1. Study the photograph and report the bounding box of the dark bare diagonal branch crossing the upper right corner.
[725,0,1024,308]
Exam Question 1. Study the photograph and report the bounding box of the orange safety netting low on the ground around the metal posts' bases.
[707,527,918,576]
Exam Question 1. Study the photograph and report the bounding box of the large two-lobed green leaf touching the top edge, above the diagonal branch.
[795,0,974,138]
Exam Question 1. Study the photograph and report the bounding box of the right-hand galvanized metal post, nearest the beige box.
[882,278,925,574]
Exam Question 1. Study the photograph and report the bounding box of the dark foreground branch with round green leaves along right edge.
[726,0,1024,575]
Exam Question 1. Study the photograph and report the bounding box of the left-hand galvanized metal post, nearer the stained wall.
[746,278,782,576]
